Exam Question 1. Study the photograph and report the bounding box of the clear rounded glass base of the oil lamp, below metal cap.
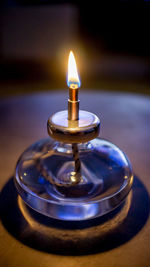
[15,138,133,221]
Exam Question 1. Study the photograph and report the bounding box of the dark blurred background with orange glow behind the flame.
[0,0,150,97]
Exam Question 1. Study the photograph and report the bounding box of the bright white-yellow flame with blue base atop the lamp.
[67,51,81,89]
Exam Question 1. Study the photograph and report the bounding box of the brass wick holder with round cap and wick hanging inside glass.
[47,85,100,186]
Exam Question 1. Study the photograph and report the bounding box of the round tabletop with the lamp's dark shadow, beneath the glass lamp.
[0,90,150,267]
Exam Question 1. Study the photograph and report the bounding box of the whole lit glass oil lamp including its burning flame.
[15,51,133,221]
